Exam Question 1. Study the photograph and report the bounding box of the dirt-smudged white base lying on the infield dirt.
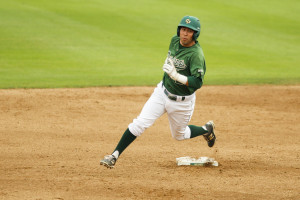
[176,156,219,167]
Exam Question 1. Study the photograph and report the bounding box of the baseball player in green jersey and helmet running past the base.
[100,16,216,168]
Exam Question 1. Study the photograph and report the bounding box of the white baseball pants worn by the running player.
[128,82,196,140]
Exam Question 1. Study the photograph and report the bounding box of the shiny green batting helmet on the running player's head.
[177,16,201,40]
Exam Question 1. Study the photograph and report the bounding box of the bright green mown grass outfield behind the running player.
[0,0,300,88]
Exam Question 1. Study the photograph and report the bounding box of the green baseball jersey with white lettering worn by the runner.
[163,35,206,96]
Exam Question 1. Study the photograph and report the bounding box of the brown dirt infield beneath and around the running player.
[0,86,300,200]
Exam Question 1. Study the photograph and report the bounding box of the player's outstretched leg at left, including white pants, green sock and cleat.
[100,84,166,168]
